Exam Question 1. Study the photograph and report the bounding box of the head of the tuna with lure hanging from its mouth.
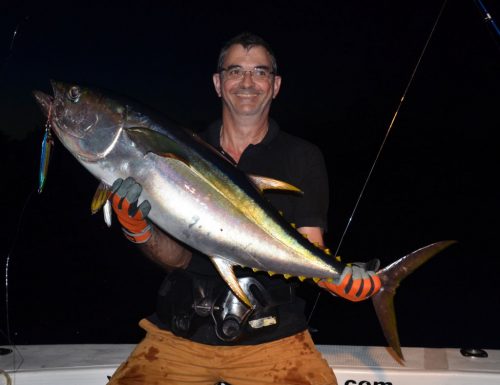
[33,81,126,162]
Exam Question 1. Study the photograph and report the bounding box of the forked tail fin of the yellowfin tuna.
[372,241,455,361]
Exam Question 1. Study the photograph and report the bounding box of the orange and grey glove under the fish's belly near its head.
[110,177,151,243]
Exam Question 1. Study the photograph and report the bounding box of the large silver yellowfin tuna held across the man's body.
[35,82,453,358]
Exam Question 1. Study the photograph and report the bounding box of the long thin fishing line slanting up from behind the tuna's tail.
[308,0,448,323]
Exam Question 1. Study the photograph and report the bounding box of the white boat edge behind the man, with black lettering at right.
[0,344,500,385]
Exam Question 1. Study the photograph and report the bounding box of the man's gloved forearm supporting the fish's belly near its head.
[110,178,192,270]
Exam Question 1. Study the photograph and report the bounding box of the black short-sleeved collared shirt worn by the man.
[150,120,329,345]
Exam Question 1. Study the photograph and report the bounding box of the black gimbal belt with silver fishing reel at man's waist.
[157,270,295,341]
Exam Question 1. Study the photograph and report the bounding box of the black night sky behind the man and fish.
[0,0,500,349]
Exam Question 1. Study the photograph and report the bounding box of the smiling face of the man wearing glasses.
[213,44,281,116]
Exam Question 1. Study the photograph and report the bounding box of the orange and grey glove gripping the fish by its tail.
[318,260,382,302]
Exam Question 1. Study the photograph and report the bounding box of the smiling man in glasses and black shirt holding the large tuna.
[106,33,380,385]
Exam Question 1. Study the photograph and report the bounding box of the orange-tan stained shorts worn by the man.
[108,319,337,385]
